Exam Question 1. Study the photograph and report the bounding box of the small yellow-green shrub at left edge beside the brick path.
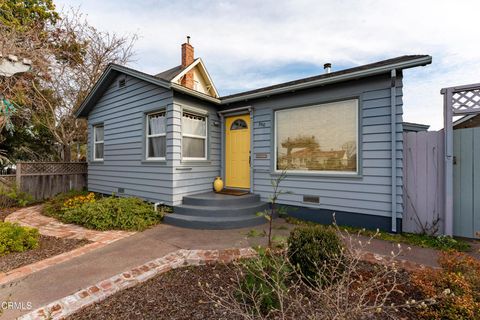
[0,222,40,255]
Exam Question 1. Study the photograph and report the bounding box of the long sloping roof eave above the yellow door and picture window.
[220,56,432,104]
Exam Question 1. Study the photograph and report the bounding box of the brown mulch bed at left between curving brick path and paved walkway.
[0,235,91,272]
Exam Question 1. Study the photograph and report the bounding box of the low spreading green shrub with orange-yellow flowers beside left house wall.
[56,197,163,231]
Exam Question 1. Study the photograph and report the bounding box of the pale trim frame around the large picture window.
[273,98,360,176]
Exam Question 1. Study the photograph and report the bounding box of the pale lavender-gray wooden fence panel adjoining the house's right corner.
[403,130,445,233]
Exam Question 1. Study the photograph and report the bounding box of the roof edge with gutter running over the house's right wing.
[221,55,432,103]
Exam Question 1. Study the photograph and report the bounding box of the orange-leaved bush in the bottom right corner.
[412,251,480,320]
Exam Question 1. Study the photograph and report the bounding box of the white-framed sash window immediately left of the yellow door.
[182,112,207,160]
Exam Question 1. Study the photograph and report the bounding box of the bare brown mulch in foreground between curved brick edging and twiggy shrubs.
[67,264,242,320]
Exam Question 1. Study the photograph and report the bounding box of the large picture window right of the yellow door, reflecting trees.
[275,99,358,173]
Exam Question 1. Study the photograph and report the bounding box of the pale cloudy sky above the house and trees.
[55,0,480,129]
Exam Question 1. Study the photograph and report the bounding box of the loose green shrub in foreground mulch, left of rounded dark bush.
[236,249,292,315]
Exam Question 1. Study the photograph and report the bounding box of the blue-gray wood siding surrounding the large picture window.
[236,75,403,217]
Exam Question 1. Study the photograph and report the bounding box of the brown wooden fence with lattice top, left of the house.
[0,162,87,200]
